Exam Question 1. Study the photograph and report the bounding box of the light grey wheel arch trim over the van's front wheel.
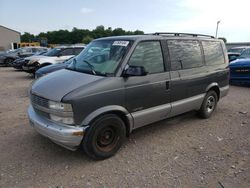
[81,105,133,132]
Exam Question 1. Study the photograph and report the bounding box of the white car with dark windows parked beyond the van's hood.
[22,46,84,73]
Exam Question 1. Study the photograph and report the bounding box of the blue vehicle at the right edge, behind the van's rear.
[229,48,250,85]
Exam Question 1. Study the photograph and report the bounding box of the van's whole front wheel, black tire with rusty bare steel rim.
[82,114,126,160]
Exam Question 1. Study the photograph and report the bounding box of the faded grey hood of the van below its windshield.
[31,69,104,102]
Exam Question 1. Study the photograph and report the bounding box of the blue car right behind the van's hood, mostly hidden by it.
[35,57,74,79]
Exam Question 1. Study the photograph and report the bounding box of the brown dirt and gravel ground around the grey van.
[0,67,250,188]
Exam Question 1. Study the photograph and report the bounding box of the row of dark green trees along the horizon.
[21,25,144,44]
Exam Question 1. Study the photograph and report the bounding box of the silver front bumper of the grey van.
[28,105,87,151]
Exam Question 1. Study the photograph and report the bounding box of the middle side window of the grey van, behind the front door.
[168,40,203,70]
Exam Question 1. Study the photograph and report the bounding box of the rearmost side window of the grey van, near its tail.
[201,41,225,65]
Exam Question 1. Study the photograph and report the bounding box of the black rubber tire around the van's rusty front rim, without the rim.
[82,114,126,160]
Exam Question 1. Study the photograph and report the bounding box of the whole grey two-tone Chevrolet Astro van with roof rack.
[28,33,229,159]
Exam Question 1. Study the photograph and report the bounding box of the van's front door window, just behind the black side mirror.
[128,41,164,74]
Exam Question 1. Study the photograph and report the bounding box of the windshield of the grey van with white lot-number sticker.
[67,40,131,76]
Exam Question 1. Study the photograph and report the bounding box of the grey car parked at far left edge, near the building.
[0,47,48,66]
